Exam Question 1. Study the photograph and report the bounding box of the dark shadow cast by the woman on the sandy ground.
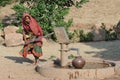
[5,56,33,64]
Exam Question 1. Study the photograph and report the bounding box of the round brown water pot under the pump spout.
[72,56,85,69]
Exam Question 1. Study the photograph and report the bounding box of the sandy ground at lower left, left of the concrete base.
[0,46,43,80]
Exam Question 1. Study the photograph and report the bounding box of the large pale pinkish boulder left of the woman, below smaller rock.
[5,33,24,47]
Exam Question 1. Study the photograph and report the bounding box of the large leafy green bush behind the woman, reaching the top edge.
[13,0,88,37]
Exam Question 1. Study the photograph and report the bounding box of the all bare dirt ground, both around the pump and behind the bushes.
[0,0,120,80]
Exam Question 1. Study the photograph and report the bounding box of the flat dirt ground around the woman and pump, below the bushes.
[0,41,120,80]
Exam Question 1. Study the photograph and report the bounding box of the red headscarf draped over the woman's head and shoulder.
[22,13,43,36]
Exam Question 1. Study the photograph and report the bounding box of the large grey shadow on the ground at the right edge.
[84,40,120,61]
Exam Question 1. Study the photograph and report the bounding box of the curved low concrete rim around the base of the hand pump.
[36,59,118,80]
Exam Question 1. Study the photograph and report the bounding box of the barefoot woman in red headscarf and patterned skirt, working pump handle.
[19,13,43,64]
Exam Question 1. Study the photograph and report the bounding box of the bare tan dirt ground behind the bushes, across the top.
[0,0,120,25]
